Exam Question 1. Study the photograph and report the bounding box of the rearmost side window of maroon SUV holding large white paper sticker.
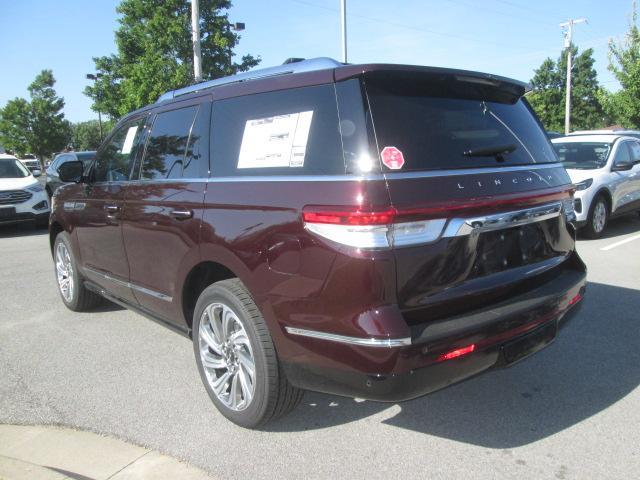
[211,85,345,176]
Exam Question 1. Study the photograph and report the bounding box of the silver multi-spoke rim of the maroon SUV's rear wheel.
[198,303,256,411]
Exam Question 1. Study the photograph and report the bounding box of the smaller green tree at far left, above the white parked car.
[0,70,71,160]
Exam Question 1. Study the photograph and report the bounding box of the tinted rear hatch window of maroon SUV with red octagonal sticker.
[366,75,558,171]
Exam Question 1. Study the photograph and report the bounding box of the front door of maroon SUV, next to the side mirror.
[76,116,146,303]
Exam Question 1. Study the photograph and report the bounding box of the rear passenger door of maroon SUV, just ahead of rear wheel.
[123,99,211,325]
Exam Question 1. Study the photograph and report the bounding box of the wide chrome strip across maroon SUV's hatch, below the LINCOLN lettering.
[442,202,562,238]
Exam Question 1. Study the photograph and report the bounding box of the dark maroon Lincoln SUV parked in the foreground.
[50,59,586,427]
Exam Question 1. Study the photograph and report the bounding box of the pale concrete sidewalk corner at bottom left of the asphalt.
[0,425,212,480]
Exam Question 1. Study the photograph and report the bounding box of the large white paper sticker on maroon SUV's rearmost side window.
[238,110,313,168]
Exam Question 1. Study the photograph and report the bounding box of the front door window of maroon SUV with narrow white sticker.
[93,118,144,182]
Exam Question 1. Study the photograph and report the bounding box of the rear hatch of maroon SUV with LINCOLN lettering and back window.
[364,70,574,325]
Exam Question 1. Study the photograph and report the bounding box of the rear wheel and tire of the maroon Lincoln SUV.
[193,278,304,428]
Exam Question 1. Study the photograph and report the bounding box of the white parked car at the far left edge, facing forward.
[0,154,50,226]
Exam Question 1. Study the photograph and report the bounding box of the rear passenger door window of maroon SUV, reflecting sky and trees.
[140,105,198,180]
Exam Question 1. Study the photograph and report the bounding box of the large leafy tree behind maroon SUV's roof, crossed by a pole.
[85,0,260,119]
